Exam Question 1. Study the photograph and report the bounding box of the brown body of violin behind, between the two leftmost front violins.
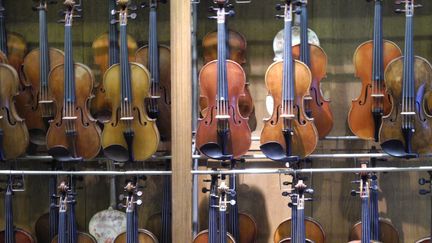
[18,48,64,145]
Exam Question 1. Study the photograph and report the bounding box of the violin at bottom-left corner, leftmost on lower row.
[0,176,36,243]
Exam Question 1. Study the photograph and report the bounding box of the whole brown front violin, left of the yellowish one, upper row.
[47,0,101,161]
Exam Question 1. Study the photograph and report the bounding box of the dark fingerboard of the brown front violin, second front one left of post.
[64,24,75,103]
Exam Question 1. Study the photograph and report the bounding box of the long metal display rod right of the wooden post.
[191,166,432,175]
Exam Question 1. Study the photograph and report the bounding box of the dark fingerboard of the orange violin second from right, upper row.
[372,1,384,84]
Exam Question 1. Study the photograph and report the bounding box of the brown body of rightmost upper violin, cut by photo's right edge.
[380,56,432,156]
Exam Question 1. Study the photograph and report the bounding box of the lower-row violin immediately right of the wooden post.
[193,175,236,243]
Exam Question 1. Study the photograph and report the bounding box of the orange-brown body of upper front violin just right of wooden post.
[196,60,251,158]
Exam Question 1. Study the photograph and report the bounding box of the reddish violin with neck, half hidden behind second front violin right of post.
[292,0,333,139]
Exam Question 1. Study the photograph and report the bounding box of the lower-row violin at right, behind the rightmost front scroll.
[349,174,399,243]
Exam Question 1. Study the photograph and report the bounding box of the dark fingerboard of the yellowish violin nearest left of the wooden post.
[120,17,132,102]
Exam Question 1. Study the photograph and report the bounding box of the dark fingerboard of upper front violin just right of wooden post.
[217,8,228,100]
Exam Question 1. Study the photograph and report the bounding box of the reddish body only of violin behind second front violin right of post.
[292,44,333,139]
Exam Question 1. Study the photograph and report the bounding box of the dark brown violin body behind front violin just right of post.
[200,30,256,127]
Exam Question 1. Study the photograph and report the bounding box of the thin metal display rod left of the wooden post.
[0,170,172,176]
